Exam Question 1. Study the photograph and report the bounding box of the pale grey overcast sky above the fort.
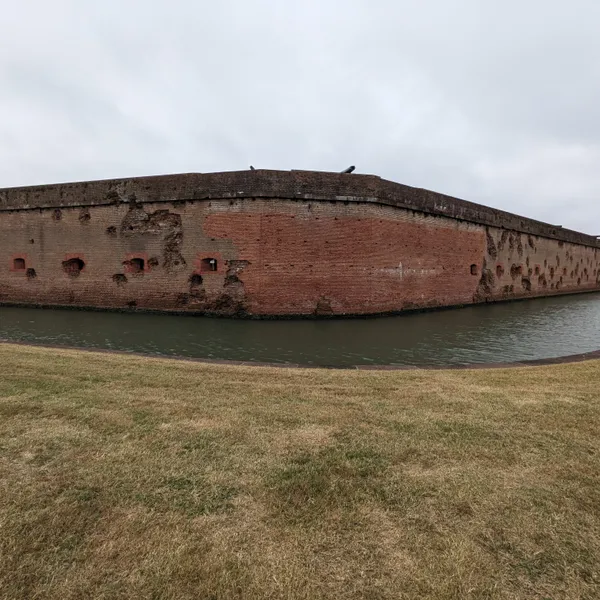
[0,0,600,235]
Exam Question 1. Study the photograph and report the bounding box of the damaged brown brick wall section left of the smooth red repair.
[0,200,250,315]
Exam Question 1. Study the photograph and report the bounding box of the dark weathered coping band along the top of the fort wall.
[0,169,600,248]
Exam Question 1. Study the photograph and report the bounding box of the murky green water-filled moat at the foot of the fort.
[0,293,600,367]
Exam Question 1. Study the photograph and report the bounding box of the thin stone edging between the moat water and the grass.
[0,338,600,371]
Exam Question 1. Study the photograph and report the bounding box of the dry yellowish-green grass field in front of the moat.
[0,344,600,600]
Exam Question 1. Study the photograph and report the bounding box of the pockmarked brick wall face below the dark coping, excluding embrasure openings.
[0,198,600,315]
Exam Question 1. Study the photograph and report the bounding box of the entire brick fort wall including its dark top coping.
[0,171,600,316]
